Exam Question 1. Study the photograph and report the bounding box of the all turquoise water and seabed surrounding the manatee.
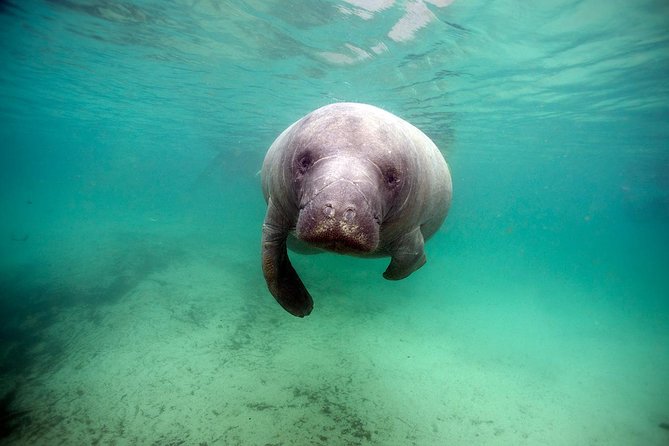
[0,0,669,445]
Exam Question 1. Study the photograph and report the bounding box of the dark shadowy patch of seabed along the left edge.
[0,235,184,438]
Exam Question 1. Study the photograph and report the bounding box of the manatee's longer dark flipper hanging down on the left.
[262,198,314,317]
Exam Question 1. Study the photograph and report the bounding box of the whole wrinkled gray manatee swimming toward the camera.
[262,103,452,317]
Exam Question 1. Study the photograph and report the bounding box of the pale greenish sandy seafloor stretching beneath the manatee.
[2,206,669,446]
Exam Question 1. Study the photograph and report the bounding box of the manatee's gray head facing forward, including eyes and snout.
[290,106,410,255]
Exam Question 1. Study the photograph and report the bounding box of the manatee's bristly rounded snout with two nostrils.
[295,181,380,254]
